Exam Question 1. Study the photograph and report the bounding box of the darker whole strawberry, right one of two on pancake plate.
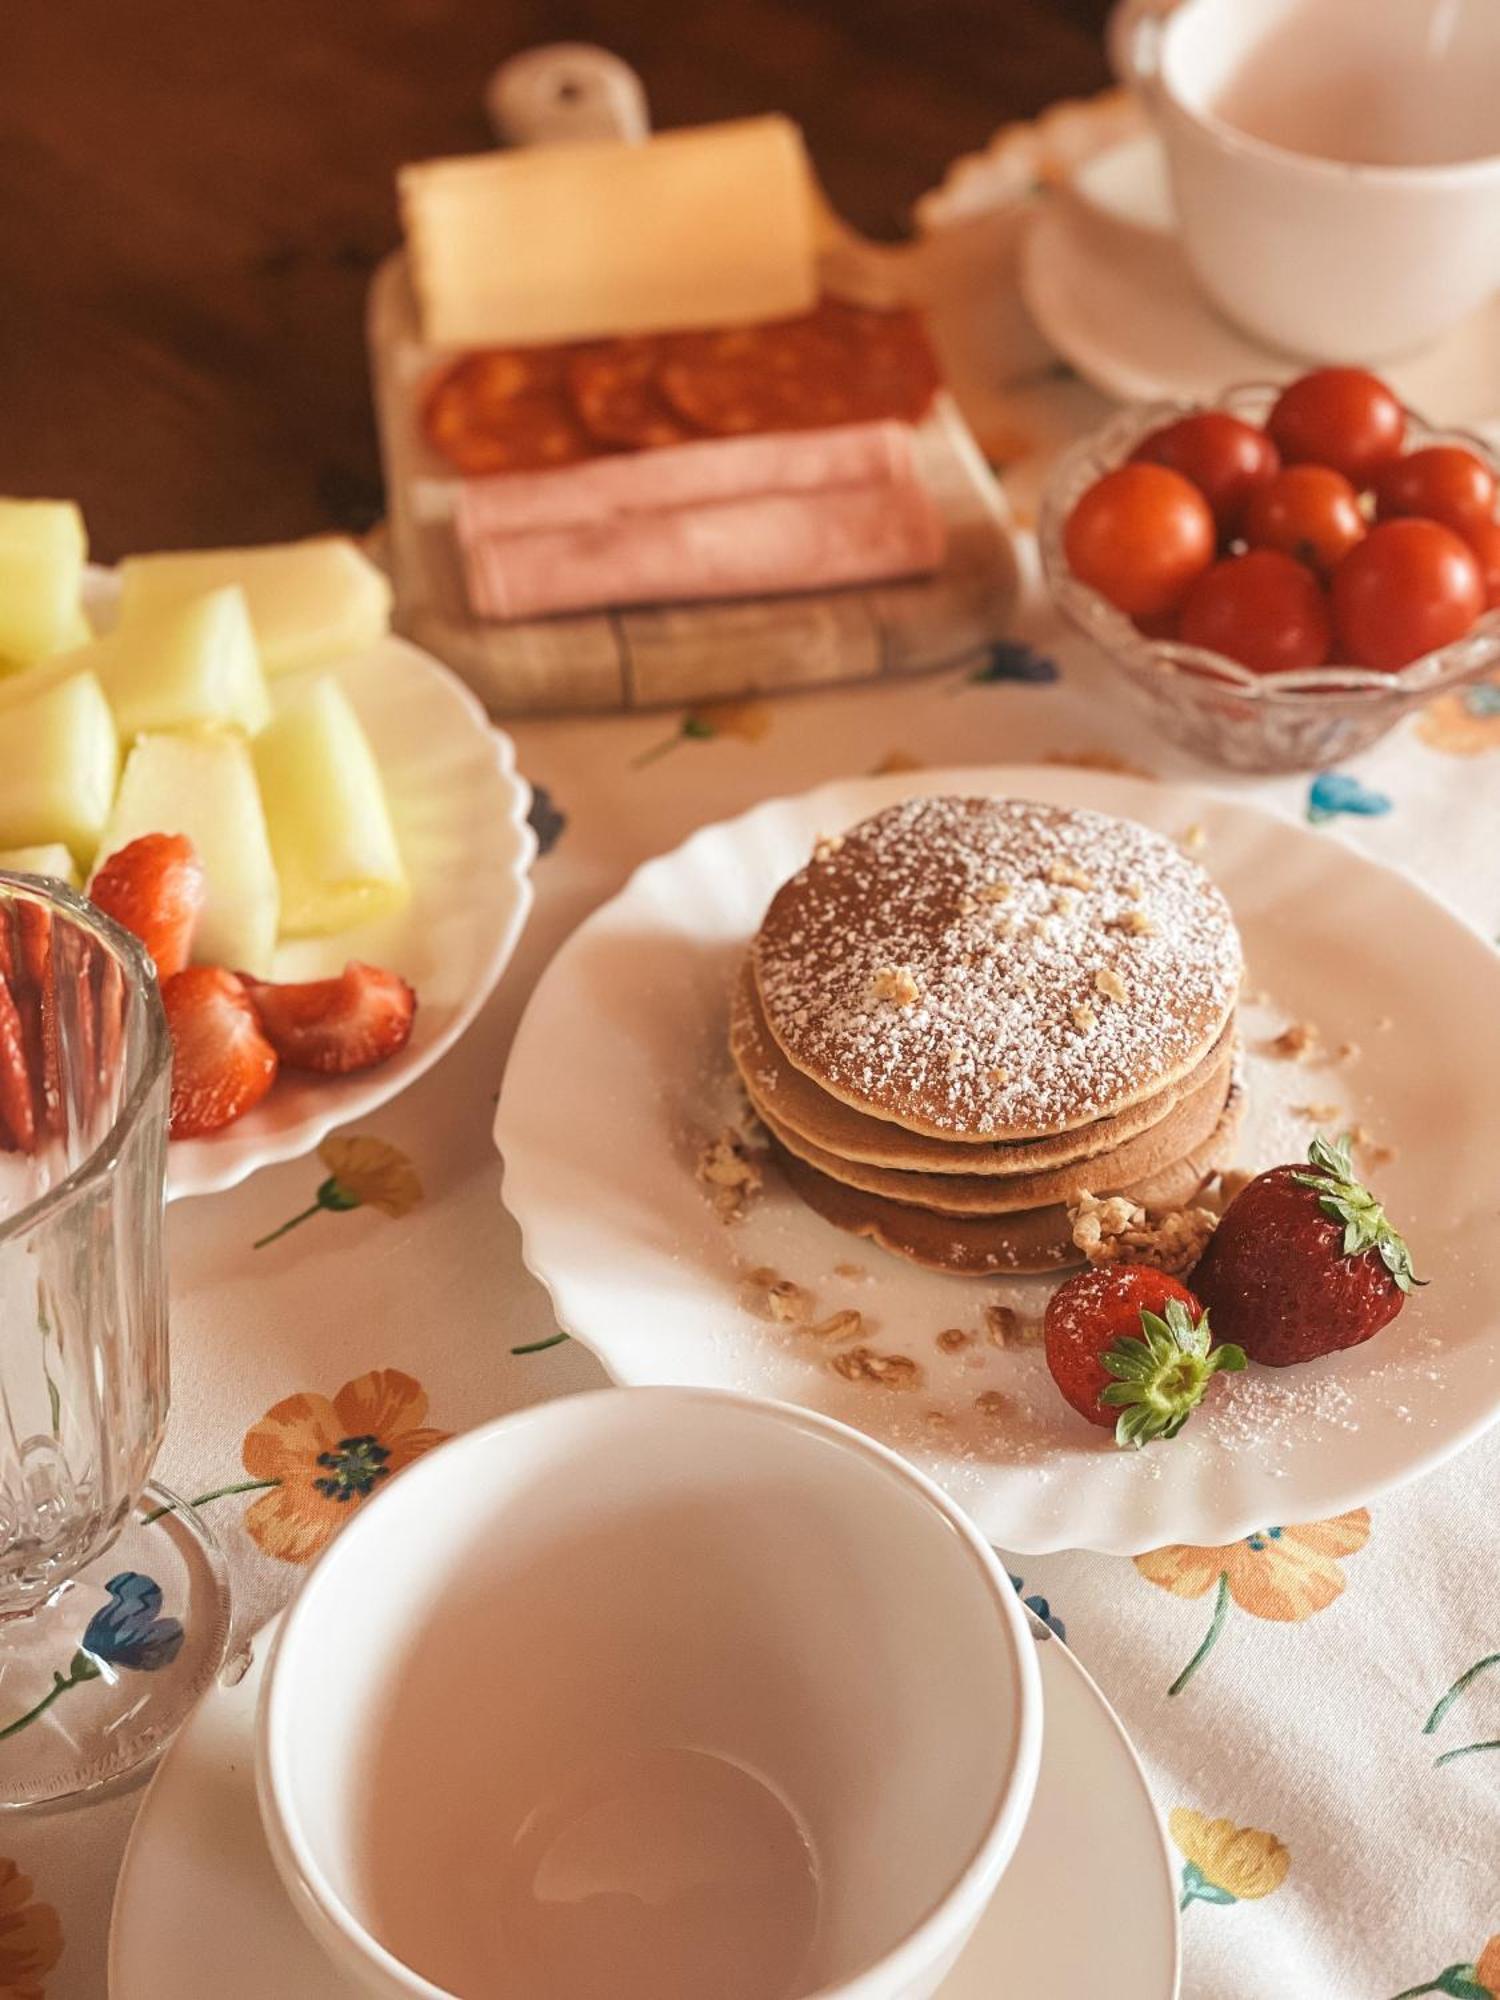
[1192,1138,1422,1368]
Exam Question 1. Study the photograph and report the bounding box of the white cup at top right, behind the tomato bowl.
[1110,0,1500,362]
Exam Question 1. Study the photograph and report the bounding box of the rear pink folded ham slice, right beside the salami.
[456,424,916,540]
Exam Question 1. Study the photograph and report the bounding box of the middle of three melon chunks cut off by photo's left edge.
[0,674,120,866]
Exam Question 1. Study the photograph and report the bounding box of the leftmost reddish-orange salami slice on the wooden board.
[422,348,596,472]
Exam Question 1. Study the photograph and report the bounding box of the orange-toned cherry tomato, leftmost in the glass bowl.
[1062,466,1214,618]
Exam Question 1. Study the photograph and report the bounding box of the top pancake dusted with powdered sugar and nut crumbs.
[752,798,1242,1142]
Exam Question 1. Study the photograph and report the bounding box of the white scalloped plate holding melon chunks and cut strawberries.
[88,570,536,1200]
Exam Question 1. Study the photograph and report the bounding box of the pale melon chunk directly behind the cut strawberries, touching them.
[100,730,276,978]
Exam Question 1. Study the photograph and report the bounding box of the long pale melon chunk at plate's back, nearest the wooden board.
[120,536,390,674]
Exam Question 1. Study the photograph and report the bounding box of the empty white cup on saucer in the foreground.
[258,1388,1040,2000]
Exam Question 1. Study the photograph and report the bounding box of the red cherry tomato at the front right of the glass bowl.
[1334,520,1484,674]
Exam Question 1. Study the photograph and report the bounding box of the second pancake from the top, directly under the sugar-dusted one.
[730,960,1234,1174]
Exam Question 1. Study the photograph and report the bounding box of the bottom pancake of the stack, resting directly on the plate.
[770,1084,1242,1278]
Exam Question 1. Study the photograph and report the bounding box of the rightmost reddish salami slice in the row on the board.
[658,300,938,436]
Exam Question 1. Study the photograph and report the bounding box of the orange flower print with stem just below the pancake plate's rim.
[1134,1508,1370,1694]
